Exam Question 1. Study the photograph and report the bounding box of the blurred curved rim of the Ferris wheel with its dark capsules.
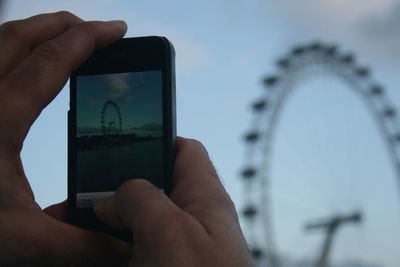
[241,42,400,267]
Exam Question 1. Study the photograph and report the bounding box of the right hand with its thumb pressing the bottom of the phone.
[95,138,252,267]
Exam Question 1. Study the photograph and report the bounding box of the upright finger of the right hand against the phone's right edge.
[170,138,239,237]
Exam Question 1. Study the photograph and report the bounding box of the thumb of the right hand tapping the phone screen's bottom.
[94,179,183,235]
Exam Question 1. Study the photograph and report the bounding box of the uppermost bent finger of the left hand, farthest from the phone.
[0,11,83,77]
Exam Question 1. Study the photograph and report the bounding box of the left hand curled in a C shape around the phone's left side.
[0,12,130,266]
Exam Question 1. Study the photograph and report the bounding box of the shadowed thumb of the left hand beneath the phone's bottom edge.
[2,211,131,266]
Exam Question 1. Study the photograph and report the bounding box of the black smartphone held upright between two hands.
[68,36,176,242]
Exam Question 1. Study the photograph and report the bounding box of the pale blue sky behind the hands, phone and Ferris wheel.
[1,0,400,267]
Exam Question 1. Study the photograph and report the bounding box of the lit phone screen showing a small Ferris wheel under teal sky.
[74,71,164,208]
